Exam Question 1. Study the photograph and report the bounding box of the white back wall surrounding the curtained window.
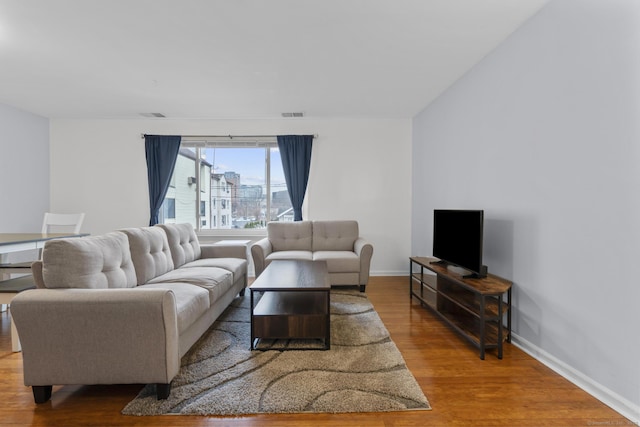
[51,119,411,275]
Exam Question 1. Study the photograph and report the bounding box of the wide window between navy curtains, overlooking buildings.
[160,137,293,231]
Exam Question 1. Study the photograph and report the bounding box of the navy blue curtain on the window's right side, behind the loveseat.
[278,135,313,221]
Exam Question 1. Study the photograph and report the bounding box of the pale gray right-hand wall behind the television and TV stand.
[412,0,640,421]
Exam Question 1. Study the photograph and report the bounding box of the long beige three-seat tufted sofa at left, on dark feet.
[11,224,247,403]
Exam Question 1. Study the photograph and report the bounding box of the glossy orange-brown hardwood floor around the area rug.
[0,277,634,427]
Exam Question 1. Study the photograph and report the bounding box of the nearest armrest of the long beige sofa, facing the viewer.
[11,288,180,386]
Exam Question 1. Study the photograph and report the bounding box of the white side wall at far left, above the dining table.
[0,104,49,233]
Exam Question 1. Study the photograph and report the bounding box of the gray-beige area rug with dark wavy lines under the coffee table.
[122,289,431,415]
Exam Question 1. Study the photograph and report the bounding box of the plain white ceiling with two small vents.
[0,0,548,118]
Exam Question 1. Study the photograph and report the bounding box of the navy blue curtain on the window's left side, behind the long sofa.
[144,135,182,225]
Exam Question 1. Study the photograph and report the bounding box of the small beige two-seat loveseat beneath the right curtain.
[251,221,373,292]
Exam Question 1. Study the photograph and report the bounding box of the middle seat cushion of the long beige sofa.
[148,267,233,305]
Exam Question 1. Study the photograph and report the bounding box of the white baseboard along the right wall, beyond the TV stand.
[511,334,640,425]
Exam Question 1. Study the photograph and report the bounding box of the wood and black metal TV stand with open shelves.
[409,257,512,359]
